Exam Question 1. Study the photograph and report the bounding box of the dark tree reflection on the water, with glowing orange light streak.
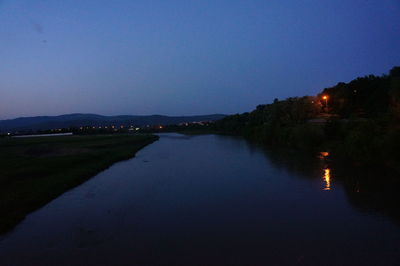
[265,147,400,225]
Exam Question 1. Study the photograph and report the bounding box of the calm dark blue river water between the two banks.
[0,134,400,265]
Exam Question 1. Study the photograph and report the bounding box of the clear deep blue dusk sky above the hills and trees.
[0,0,400,119]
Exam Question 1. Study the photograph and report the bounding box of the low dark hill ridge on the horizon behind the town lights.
[0,114,225,132]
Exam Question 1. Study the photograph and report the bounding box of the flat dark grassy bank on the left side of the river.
[0,135,158,233]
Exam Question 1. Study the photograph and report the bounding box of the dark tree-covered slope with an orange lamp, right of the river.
[215,67,400,172]
